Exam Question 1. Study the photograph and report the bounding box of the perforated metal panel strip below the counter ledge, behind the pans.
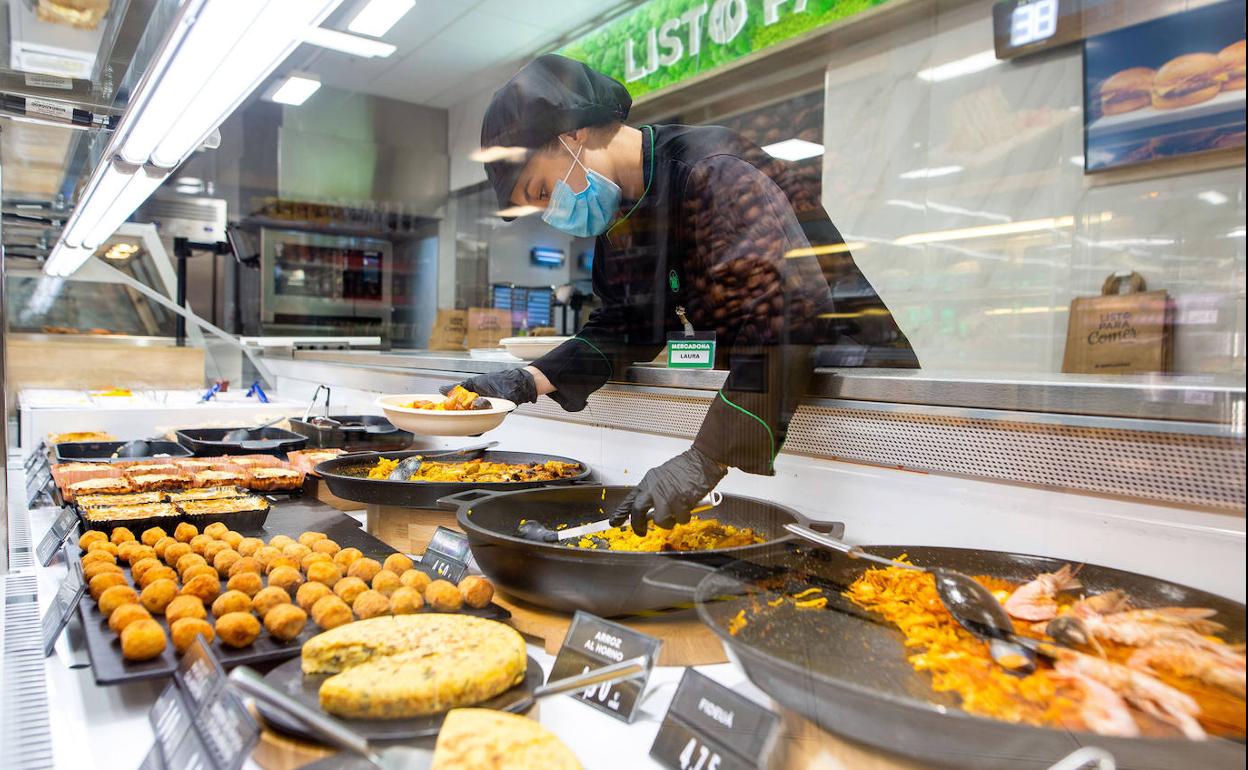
[522,391,1244,510]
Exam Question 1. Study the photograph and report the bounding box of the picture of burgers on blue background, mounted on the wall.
[1083,0,1246,171]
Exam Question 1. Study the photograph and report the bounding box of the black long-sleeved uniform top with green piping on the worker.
[533,126,915,474]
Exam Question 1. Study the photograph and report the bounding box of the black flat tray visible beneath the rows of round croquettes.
[79,500,512,685]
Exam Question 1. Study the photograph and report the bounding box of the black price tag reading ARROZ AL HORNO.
[548,610,663,723]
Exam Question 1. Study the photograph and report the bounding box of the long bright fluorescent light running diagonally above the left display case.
[44,0,341,275]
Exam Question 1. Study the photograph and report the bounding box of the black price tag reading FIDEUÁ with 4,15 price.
[650,669,780,770]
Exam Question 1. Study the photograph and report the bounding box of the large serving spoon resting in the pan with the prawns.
[784,524,1036,674]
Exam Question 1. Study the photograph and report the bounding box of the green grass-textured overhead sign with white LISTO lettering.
[559,0,889,99]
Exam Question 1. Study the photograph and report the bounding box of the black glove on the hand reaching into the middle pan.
[610,447,728,535]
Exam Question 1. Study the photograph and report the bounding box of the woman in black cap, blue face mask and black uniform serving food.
[444,54,917,534]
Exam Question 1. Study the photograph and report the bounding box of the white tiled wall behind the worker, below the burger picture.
[824,2,1246,376]
